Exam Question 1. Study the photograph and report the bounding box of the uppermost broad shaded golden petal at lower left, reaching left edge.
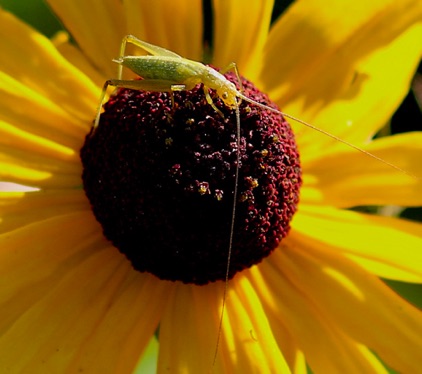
[0,212,104,331]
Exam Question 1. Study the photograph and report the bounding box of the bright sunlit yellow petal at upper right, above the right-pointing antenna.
[294,22,422,152]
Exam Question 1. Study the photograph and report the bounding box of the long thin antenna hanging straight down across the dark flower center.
[212,105,240,366]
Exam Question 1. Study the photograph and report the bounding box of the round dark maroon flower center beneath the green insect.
[81,74,301,284]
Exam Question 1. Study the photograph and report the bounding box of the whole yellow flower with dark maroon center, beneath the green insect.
[0,0,422,373]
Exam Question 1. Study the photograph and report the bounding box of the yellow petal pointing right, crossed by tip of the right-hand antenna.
[302,132,422,207]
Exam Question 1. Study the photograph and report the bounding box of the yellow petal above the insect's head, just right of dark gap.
[213,0,274,81]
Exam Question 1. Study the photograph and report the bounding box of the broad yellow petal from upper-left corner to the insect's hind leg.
[0,10,100,123]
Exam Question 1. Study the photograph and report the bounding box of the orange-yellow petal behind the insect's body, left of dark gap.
[125,0,203,60]
